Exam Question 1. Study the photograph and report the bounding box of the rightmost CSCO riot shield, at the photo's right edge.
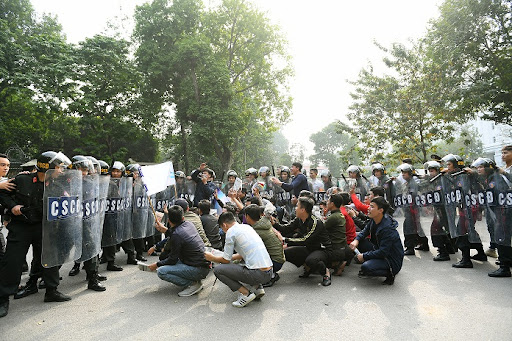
[486,172,512,246]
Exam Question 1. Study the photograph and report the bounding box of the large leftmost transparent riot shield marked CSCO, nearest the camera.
[41,169,82,268]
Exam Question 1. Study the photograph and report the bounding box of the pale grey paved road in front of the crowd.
[0,218,512,340]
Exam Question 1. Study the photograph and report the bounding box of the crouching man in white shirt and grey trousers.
[205,212,272,308]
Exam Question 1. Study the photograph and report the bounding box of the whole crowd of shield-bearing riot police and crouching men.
[0,146,512,316]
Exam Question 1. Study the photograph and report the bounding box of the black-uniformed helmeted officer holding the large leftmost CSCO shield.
[0,151,71,317]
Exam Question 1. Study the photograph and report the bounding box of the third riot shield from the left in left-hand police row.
[101,178,124,247]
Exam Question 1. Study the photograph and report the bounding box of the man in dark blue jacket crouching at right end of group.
[349,197,404,285]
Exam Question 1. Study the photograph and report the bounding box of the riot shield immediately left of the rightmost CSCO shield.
[454,173,482,243]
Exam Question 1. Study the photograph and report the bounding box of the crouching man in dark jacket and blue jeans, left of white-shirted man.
[149,205,210,297]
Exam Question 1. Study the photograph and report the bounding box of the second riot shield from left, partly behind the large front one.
[78,174,101,262]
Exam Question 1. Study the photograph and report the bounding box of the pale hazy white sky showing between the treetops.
[31,0,442,153]
